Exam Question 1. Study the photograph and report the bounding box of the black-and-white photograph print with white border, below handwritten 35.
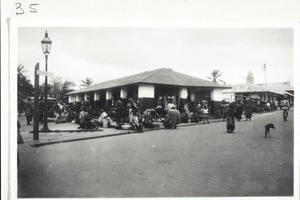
[11,22,298,199]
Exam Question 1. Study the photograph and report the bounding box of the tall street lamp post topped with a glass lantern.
[41,31,52,132]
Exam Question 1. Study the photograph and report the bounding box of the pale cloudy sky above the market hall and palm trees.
[18,27,294,89]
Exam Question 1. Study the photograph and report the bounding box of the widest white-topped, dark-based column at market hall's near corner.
[138,84,155,112]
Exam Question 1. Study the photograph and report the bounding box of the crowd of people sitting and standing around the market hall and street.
[20,95,289,133]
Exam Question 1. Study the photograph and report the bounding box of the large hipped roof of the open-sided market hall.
[68,68,230,95]
